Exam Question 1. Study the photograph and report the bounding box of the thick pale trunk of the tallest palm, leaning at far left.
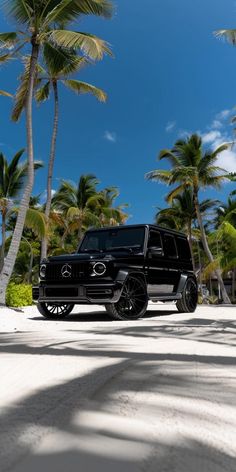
[0,37,39,305]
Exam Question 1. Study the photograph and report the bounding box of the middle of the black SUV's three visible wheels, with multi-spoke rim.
[105,276,148,320]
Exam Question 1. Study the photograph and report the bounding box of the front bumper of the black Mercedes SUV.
[32,282,123,304]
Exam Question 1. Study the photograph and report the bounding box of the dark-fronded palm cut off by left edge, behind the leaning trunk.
[0,149,43,271]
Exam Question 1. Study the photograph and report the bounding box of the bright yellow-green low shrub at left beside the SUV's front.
[6,282,33,307]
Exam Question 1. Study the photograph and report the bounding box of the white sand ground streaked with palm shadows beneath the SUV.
[0,304,236,472]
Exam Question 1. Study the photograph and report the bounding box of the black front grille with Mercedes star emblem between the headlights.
[46,263,86,282]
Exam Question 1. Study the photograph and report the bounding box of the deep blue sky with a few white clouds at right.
[0,0,236,223]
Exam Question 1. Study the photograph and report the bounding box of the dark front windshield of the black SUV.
[79,228,145,252]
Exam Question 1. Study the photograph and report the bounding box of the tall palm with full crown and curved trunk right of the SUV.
[146,134,230,303]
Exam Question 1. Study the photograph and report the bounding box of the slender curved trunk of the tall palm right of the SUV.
[194,190,231,304]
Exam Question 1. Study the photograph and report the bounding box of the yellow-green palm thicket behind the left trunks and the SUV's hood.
[6,174,128,283]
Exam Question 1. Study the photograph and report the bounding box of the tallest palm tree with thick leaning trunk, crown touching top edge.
[0,0,112,305]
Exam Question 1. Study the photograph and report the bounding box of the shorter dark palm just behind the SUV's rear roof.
[156,187,217,271]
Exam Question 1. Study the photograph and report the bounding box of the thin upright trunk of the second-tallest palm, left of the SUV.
[41,80,59,260]
